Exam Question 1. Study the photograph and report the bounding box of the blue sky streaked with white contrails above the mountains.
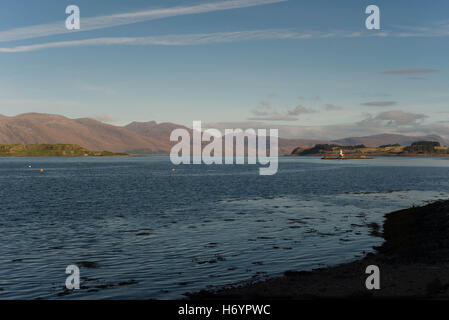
[0,0,449,139]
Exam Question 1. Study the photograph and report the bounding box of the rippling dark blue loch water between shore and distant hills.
[0,157,449,299]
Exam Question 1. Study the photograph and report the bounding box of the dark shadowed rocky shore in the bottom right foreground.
[188,200,449,300]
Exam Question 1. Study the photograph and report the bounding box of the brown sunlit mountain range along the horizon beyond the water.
[0,113,449,155]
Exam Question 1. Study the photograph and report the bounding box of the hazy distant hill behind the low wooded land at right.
[331,133,449,147]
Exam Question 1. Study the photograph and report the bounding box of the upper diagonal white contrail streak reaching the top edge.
[0,0,287,42]
